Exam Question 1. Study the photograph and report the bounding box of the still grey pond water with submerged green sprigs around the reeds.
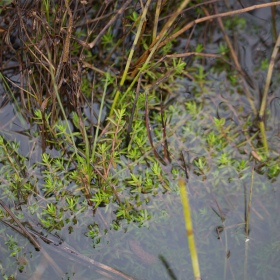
[0,1,280,280]
